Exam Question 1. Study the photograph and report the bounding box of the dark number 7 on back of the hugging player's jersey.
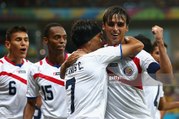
[66,77,76,114]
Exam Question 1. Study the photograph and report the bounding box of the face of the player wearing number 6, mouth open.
[5,32,29,60]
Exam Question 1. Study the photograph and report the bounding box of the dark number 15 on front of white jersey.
[41,85,53,100]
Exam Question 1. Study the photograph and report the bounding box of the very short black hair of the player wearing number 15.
[43,23,63,37]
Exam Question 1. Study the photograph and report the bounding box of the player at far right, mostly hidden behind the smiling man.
[135,32,179,119]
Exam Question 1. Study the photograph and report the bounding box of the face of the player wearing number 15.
[46,26,67,54]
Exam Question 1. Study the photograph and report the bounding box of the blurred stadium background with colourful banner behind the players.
[0,0,179,119]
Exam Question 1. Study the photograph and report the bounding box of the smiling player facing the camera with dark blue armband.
[103,6,173,119]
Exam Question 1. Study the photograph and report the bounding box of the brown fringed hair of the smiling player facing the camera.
[103,5,130,26]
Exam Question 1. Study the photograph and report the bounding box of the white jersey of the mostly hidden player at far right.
[143,72,164,119]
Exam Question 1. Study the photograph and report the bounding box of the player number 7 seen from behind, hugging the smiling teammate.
[61,20,143,119]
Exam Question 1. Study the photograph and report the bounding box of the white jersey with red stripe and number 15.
[26,55,67,119]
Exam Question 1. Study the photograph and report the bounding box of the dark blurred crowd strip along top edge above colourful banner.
[0,0,179,8]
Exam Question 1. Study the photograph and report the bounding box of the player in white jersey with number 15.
[24,23,69,119]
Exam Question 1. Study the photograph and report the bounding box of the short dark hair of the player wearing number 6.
[6,26,28,41]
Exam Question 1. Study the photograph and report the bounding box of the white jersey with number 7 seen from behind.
[65,45,122,119]
